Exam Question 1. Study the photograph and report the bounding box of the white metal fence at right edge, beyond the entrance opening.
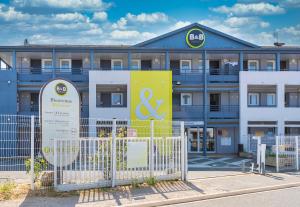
[248,135,300,172]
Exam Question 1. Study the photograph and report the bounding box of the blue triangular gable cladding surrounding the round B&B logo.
[142,29,250,49]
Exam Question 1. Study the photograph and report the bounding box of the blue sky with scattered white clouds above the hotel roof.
[0,0,300,45]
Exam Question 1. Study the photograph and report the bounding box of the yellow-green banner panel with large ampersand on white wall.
[130,71,172,137]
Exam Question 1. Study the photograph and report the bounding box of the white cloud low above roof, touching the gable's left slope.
[111,30,156,40]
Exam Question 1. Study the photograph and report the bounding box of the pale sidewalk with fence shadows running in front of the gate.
[0,171,300,207]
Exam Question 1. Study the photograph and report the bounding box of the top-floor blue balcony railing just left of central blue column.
[172,69,203,84]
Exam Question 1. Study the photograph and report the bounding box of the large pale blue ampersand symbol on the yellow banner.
[135,88,165,120]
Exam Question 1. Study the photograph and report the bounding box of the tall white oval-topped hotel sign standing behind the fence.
[40,79,80,184]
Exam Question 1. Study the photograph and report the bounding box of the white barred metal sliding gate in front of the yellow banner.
[53,120,187,191]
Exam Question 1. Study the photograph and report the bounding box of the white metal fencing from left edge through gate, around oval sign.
[0,115,187,190]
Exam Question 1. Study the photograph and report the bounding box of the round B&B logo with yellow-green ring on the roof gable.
[185,28,205,48]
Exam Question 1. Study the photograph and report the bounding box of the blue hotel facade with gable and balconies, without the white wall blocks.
[0,24,300,153]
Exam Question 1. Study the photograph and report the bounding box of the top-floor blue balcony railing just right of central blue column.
[208,68,239,83]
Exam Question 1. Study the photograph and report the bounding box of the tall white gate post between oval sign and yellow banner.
[110,119,117,187]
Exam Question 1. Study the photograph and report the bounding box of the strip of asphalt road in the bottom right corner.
[166,187,300,207]
